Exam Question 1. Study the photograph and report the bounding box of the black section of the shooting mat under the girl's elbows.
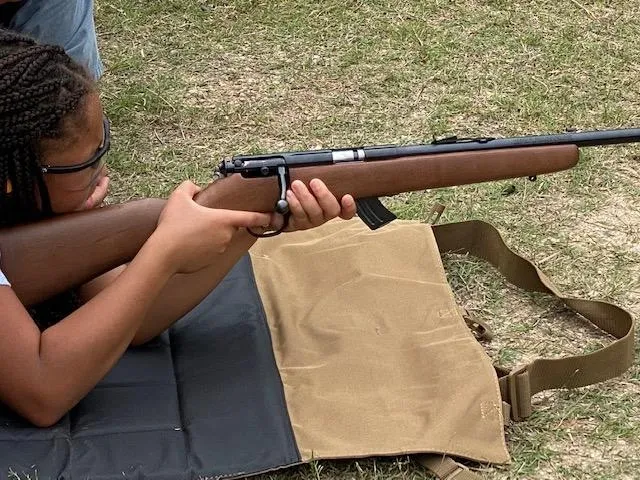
[0,257,300,480]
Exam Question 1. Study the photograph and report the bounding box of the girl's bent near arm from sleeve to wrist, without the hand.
[0,234,174,426]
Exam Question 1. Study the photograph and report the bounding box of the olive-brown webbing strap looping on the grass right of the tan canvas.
[432,220,635,421]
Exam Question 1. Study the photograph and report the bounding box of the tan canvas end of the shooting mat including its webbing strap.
[250,220,634,480]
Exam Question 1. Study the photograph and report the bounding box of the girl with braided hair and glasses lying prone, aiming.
[0,30,355,426]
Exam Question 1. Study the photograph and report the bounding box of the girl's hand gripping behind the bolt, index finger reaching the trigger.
[156,182,271,273]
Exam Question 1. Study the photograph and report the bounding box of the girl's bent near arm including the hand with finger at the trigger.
[0,184,270,426]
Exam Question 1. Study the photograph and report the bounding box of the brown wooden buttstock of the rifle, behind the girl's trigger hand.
[0,199,165,305]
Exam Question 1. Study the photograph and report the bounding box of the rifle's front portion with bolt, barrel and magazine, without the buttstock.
[209,128,640,233]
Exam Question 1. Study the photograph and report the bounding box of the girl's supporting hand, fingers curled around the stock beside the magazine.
[271,178,356,232]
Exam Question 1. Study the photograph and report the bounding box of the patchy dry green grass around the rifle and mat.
[91,0,640,480]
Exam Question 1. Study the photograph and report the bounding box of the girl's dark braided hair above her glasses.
[0,28,95,330]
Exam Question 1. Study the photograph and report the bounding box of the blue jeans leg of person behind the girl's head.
[9,0,103,80]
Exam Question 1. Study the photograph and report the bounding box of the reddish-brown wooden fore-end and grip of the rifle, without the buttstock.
[200,145,579,212]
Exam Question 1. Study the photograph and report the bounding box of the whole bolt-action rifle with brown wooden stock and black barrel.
[0,128,640,304]
